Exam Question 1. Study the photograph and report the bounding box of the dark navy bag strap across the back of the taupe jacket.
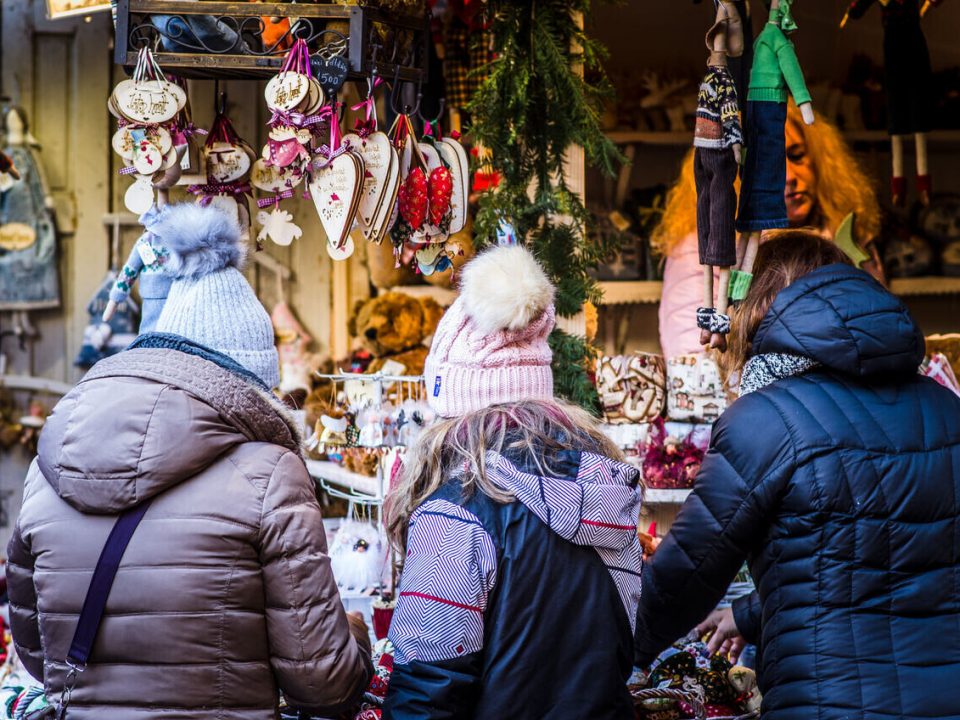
[24,500,150,720]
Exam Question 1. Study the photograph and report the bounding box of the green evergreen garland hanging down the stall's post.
[470,0,622,412]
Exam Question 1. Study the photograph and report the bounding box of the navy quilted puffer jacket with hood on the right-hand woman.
[636,265,960,720]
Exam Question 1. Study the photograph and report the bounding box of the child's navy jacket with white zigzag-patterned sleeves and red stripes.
[383,451,641,720]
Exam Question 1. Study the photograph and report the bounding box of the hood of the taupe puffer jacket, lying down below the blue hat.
[38,349,300,514]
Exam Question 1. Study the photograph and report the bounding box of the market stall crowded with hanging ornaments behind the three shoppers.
[0,0,960,718]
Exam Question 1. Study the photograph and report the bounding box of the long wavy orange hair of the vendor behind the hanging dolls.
[650,100,880,257]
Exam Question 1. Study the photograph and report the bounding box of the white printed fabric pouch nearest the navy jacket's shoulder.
[667,354,727,423]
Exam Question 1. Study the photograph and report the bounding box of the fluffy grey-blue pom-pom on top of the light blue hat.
[150,203,247,278]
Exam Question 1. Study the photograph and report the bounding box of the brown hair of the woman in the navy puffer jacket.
[719,230,852,378]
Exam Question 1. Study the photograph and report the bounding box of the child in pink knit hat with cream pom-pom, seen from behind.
[383,246,642,720]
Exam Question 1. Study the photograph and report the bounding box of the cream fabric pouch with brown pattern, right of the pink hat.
[597,352,667,425]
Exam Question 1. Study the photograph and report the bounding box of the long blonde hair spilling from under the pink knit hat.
[384,400,623,563]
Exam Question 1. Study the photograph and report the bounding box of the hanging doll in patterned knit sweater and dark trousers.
[693,0,743,350]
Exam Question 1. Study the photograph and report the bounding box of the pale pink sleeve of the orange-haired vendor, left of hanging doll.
[660,233,703,358]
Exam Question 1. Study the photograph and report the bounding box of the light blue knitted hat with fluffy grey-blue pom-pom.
[152,203,280,388]
